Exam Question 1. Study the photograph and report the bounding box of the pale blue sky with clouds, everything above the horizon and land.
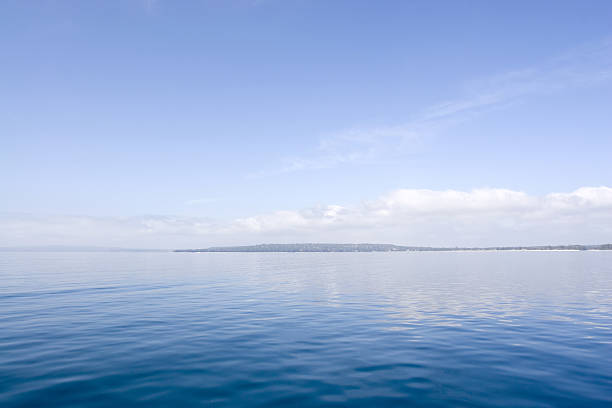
[0,0,612,248]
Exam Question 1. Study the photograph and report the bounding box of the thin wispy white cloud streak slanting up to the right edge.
[250,38,612,177]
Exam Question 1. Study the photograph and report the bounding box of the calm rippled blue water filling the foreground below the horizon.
[0,252,612,407]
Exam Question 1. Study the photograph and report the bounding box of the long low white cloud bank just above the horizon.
[0,187,612,248]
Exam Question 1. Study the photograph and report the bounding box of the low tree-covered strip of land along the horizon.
[174,243,612,252]
